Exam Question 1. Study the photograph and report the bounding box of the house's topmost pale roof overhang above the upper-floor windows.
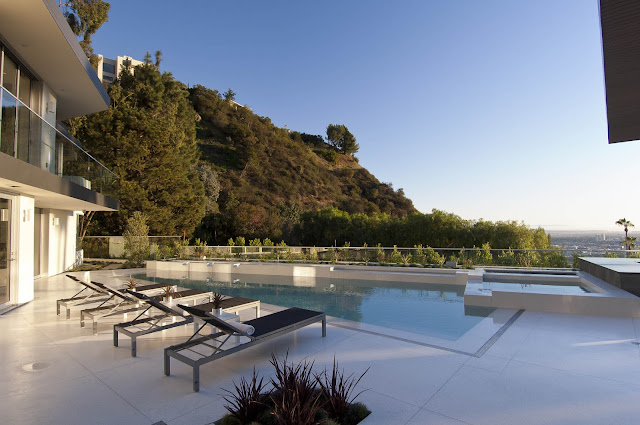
[0,0,109,120]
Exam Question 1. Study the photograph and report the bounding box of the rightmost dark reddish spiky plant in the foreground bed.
[315,356,369,423]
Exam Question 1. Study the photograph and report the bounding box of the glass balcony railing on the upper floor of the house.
[0,88,118,194]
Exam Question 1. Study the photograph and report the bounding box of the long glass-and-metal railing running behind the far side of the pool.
[84,236,640,268]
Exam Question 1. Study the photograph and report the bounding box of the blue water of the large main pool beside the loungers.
[134,275,495,341]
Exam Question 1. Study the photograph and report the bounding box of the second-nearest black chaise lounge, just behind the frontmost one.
[113,290,260,357]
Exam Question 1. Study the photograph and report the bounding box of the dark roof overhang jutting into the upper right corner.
[600,0,640,143]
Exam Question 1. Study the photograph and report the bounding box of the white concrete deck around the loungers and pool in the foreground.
[0,272,640,425]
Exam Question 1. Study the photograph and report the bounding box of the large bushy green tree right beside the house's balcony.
[74,64,206,235]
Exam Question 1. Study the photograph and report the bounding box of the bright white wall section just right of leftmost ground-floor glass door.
[11,196,34,304]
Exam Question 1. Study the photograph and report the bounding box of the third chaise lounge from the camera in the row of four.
[80,282,213,335]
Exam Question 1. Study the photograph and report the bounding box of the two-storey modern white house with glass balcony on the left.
[0,0,118,309]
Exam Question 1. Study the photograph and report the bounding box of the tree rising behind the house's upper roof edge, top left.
[60,0,111,67]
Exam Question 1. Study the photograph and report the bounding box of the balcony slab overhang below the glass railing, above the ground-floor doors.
[0,153,120,211]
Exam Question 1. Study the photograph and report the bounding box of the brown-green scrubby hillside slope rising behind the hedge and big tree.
[189,86,416,243]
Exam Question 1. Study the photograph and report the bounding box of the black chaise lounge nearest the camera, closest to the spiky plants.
[164,305,327,391]
